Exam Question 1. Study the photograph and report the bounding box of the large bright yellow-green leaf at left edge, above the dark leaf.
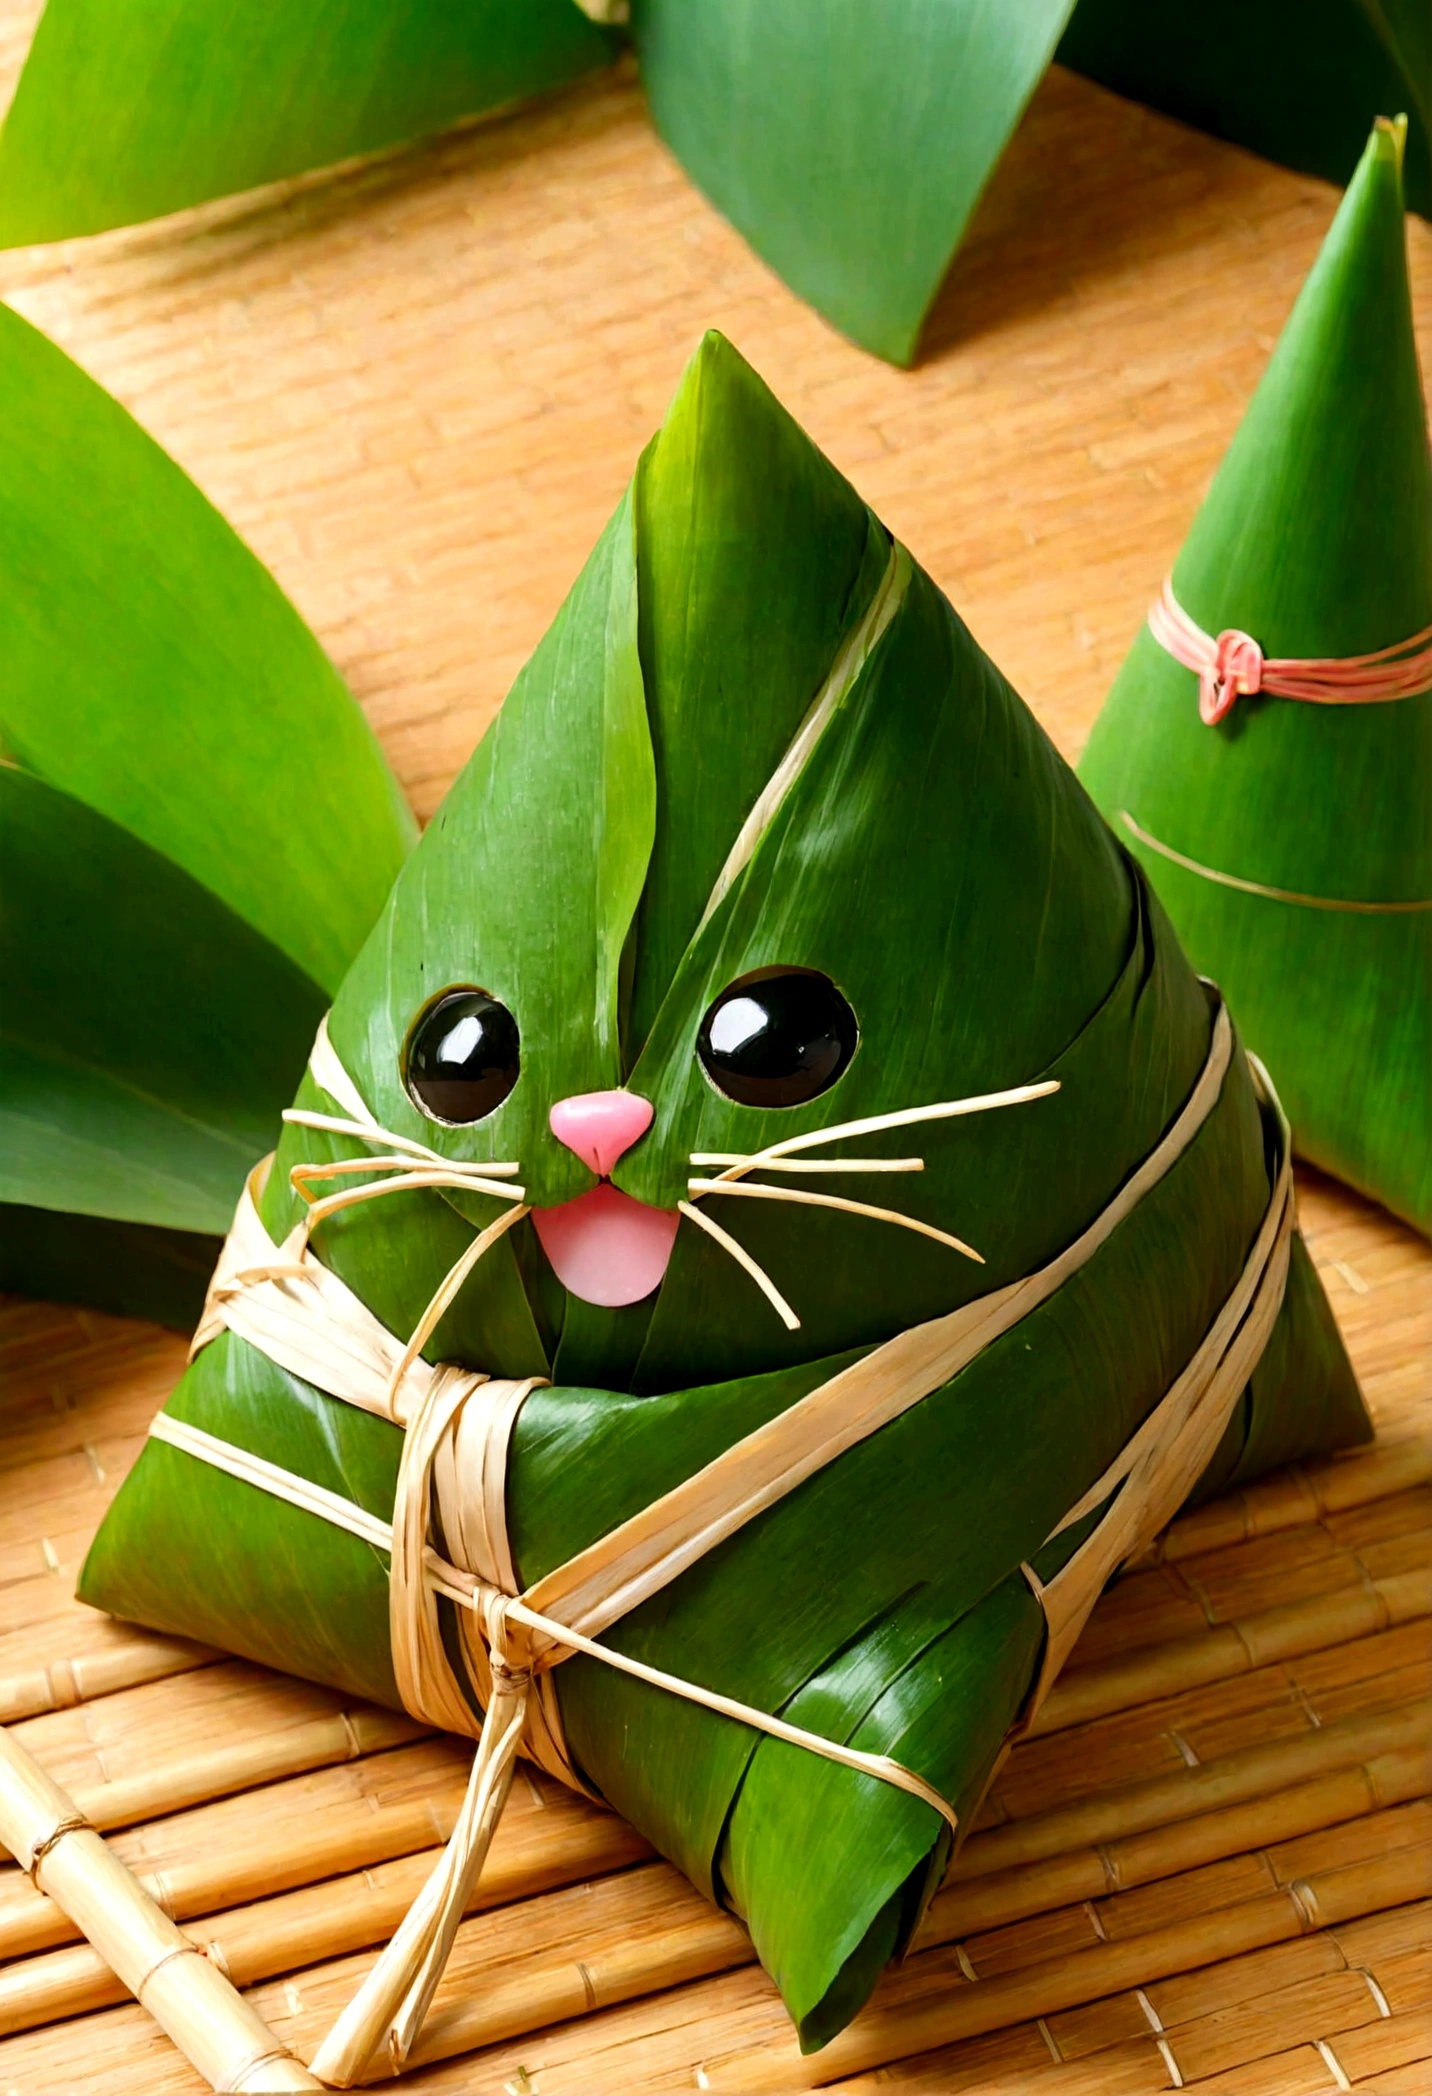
[0,308,413,989]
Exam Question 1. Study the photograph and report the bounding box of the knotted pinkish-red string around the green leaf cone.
[1149,578,1432,727]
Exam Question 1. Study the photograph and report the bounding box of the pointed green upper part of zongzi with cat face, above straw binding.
[293,344,1132,1388]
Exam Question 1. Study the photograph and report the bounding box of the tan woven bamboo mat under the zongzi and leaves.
[0,20,1432,2096]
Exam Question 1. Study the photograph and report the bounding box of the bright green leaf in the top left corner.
[0,0,614,247]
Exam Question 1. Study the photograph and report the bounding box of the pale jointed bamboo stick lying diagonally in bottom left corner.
[0,1729,323,2092]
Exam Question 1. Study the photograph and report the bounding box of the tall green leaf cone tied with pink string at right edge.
[1080,128,1432,1230]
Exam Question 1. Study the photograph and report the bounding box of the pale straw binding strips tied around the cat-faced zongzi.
[153,1004,1294,2088]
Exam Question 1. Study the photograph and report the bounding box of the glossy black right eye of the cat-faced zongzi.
[696,968,860,1107]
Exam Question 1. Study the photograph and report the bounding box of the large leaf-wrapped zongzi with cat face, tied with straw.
[82,335,1369,2086]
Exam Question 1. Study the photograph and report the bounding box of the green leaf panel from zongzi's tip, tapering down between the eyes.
[627,333,889,1063]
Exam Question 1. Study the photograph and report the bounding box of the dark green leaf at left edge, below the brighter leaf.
[0,765,323,1235]
